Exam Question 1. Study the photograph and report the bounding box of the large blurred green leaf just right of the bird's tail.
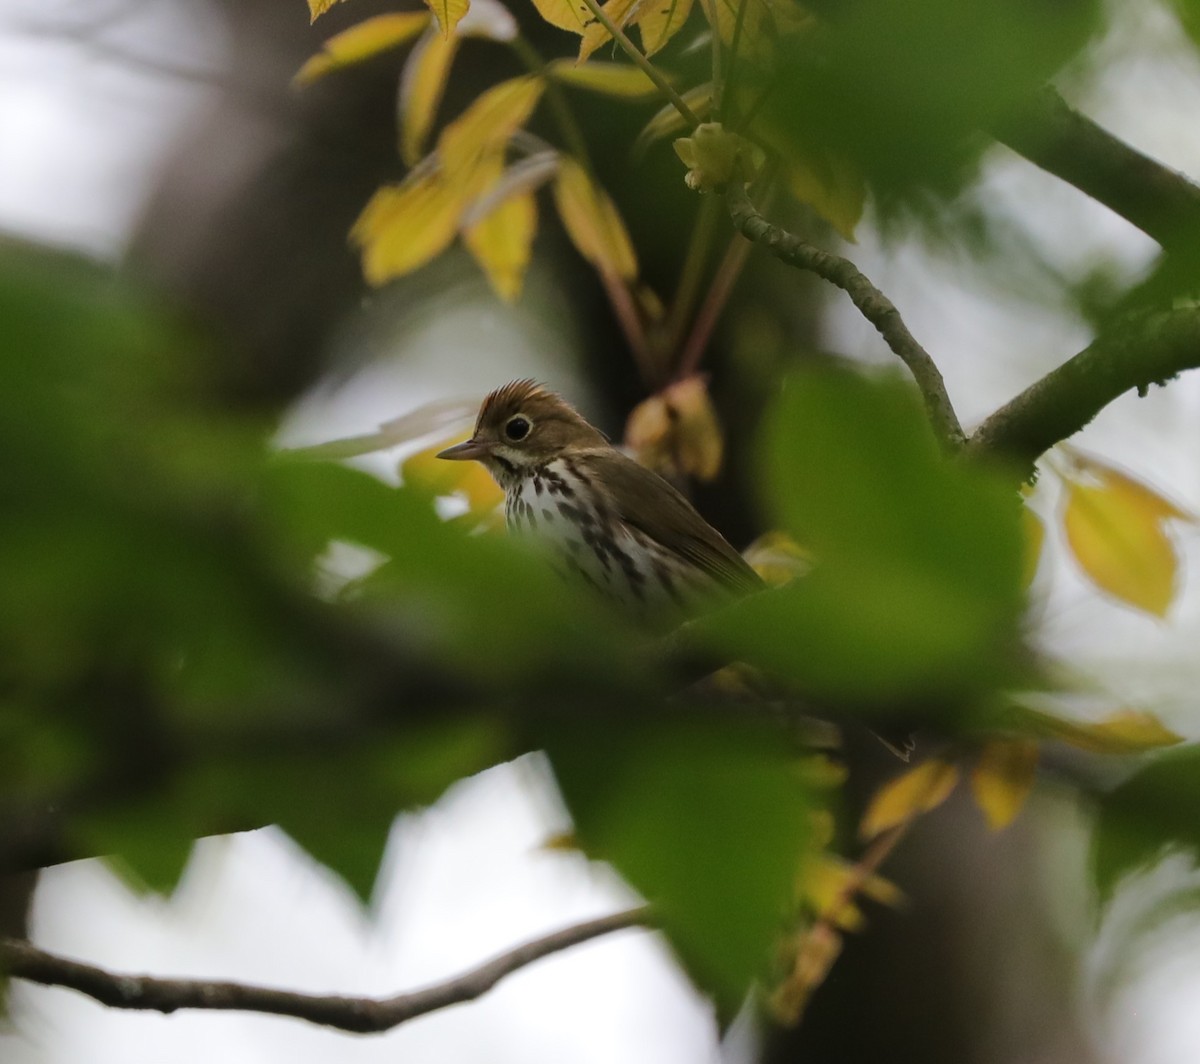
[696,372,1022,704]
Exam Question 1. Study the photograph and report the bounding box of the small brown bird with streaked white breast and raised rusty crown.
[438,380,762,619]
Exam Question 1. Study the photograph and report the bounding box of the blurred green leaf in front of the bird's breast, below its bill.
[268,462,644,687]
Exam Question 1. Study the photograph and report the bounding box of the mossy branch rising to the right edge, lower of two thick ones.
[967,307,1200,471]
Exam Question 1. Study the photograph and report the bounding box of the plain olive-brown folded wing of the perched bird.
[585,450,762,594]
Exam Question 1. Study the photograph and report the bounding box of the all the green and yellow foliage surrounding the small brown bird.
[0,0,1196,1041]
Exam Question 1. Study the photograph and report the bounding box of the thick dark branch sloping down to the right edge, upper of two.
[994,88,1200,253]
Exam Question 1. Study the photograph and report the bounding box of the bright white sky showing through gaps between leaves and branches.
[0,0,1200,1064]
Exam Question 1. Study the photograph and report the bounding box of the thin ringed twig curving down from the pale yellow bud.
[725,181,964,450]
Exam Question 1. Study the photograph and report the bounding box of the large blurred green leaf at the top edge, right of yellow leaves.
[766,0,1100,201]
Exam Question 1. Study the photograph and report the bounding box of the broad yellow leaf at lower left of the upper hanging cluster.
[350,169,479,285]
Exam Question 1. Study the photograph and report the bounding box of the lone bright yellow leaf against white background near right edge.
[1063,461,1192,617]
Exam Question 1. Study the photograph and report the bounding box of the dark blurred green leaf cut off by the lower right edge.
[1092,746,1200,903]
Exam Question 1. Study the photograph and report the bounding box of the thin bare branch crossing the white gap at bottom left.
[0,907,649,1034]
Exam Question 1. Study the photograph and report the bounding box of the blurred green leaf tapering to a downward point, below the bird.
[546,716,810,1016]
